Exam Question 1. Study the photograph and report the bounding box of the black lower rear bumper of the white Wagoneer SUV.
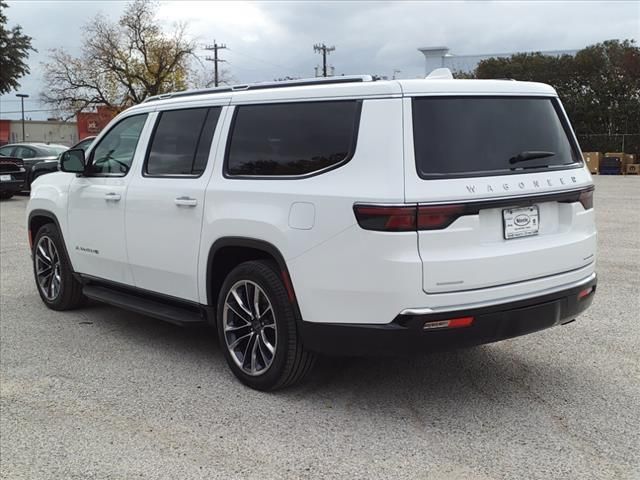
[301,276,597,356]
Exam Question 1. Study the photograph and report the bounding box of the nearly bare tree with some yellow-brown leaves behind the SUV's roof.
[41,0,196,114]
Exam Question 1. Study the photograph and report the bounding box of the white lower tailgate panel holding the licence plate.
[418,188,596,293]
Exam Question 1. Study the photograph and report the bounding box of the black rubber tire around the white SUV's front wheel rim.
[32,223,86,310]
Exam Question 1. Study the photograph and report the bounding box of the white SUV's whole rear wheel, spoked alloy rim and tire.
[216,260,315,390]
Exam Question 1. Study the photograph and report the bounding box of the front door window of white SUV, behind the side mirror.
[90,113,147,176]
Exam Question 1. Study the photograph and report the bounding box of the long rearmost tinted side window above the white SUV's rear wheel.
[225,100,361,176]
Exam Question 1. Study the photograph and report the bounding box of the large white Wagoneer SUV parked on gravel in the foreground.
[27,74,596,390]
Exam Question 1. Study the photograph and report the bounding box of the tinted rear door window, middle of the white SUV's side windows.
[144,107,221,176]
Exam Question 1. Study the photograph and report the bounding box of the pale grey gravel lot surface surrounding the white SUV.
[0,177,640,480]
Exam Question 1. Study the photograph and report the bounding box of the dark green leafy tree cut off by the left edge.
[0,0,36,95]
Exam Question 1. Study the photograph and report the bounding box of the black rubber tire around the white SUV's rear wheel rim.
[216,260,316,391]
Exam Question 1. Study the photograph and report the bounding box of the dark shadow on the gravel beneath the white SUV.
[77,302,571,404]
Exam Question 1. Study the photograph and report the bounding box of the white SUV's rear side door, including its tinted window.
[126,105,228,302]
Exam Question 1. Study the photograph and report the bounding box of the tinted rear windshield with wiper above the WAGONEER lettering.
[413,97,580,179]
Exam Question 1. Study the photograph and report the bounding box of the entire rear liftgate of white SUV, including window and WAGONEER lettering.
[404,96,596,293]
